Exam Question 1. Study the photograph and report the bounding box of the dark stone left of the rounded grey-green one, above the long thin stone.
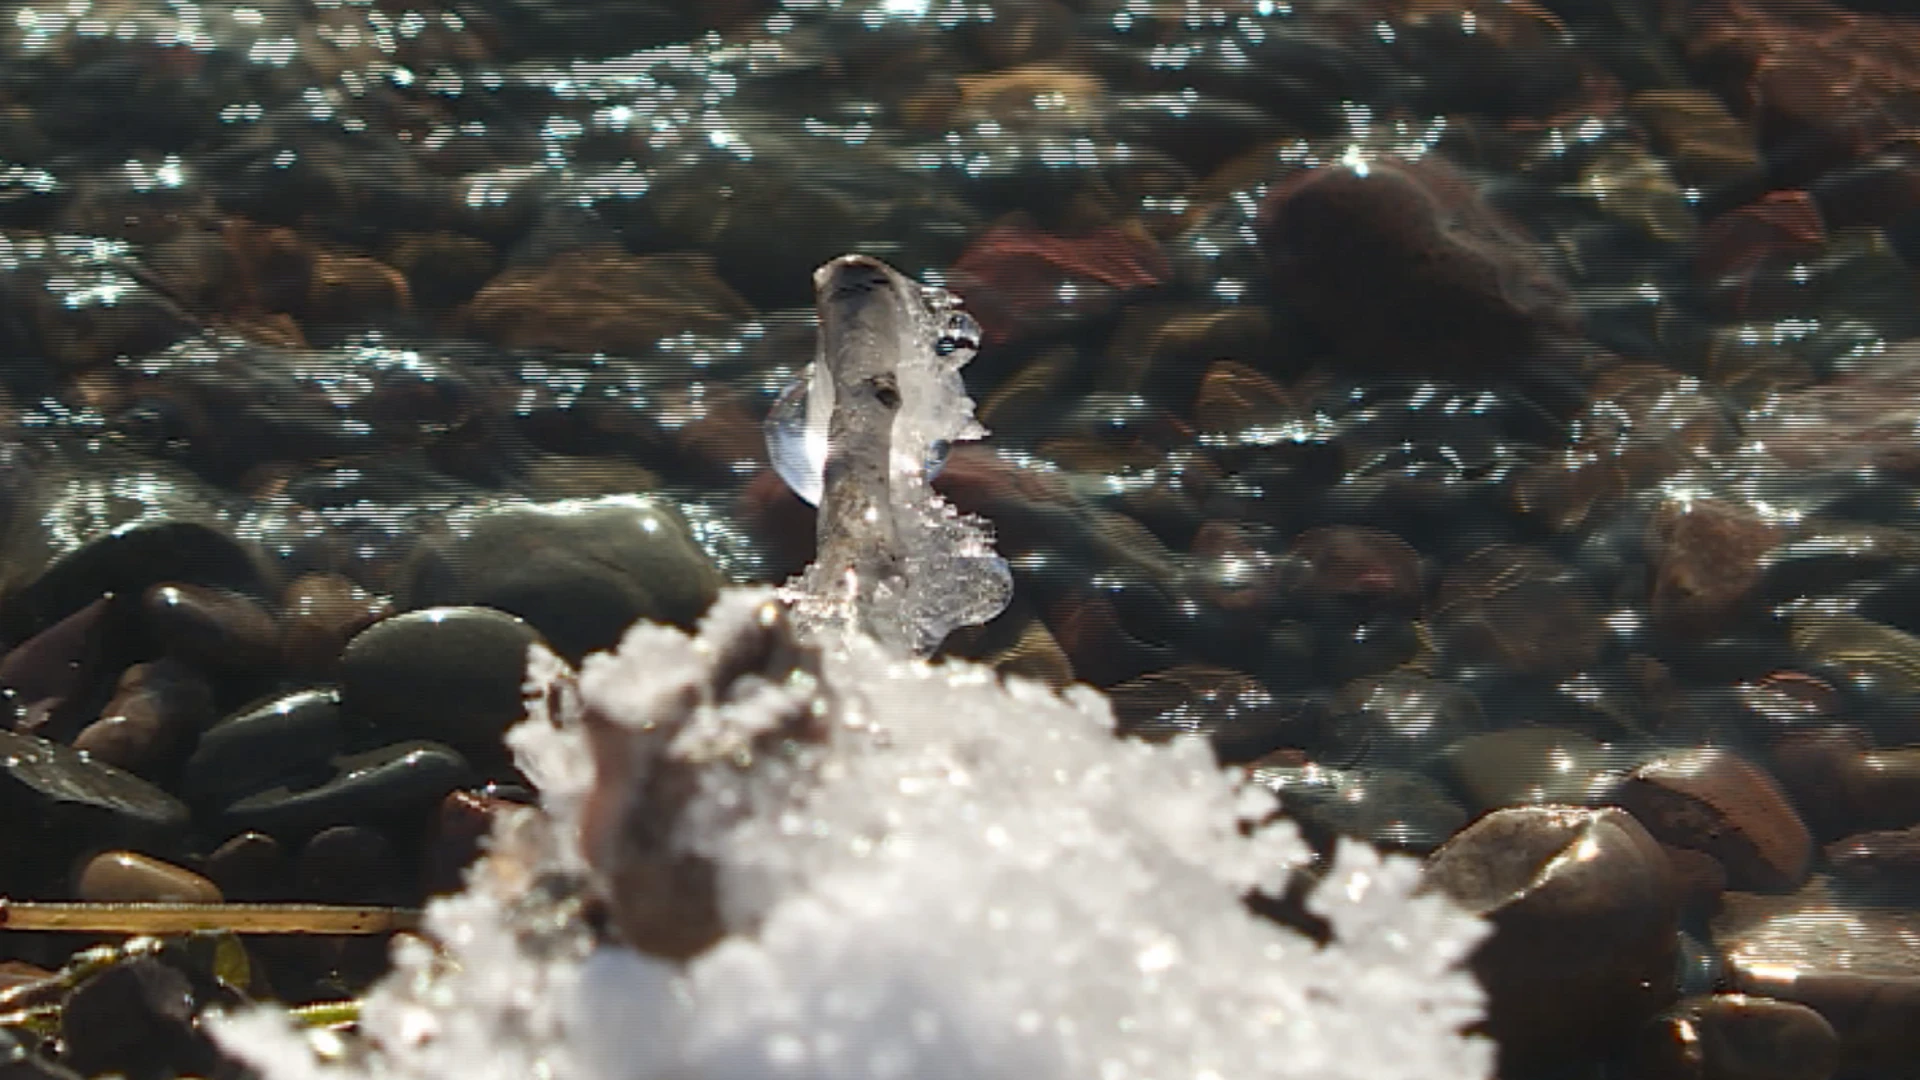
[180,688,346,801]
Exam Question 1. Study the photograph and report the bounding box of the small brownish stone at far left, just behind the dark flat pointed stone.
[73,659,213,780]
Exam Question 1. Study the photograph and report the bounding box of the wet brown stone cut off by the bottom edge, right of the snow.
[1634,994,1839,1080]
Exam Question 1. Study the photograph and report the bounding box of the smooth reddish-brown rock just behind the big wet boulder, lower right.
[1615,748,1812,892]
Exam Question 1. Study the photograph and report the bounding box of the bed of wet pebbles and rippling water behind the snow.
[0,0,1920,1080]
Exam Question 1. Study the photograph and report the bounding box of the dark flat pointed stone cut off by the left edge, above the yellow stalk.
[0,730,188,872]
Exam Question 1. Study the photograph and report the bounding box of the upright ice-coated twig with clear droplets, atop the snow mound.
[766,256,1014,655]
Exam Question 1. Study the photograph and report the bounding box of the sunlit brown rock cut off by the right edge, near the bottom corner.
[1713,878,1920,1080]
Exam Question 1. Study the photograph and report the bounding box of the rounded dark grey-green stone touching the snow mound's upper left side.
[340,607,540,753]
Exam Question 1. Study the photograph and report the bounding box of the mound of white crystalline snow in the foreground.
[209,259,1492,1080]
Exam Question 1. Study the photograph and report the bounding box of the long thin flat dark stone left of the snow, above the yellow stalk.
[221,740,470,842]
